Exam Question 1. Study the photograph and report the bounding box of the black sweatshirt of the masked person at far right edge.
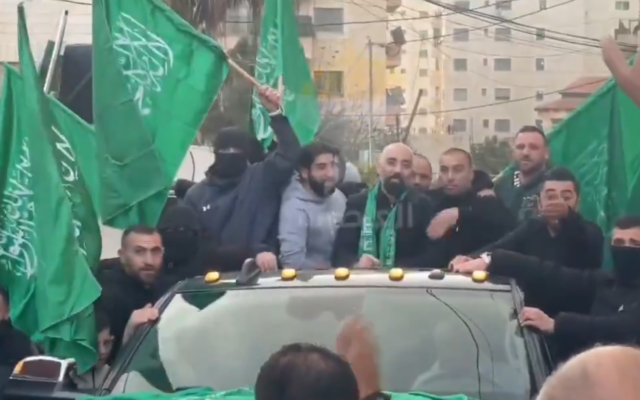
[488,250,640,358]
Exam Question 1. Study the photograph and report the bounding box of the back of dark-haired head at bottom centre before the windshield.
[255,343,359,400]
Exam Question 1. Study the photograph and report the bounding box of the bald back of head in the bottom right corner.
[538,346,640,400]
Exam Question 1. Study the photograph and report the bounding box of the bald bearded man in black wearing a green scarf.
[331,143,446,268]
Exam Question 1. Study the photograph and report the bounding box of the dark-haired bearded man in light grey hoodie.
[278,142,347,269]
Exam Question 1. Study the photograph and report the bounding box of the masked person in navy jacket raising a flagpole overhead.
[185,87,300,270]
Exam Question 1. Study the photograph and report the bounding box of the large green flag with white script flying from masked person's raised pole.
[93,0,228,228]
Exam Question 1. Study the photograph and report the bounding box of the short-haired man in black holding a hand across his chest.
[427,148,516,261]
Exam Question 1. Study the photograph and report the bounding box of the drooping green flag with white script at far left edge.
[0,5,100,372]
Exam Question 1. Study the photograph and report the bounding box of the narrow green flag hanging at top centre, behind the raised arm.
[251,0,320,145]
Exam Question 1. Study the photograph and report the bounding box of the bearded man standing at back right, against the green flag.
[494,126,549,221]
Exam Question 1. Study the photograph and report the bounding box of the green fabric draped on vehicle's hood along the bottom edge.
[80,388,475,400]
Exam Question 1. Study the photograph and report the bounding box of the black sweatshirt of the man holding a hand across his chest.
[429,189,516,262]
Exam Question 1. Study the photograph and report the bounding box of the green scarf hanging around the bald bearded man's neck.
[358,182,406,269]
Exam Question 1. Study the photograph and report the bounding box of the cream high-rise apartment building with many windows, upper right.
[439,0,638,142]
